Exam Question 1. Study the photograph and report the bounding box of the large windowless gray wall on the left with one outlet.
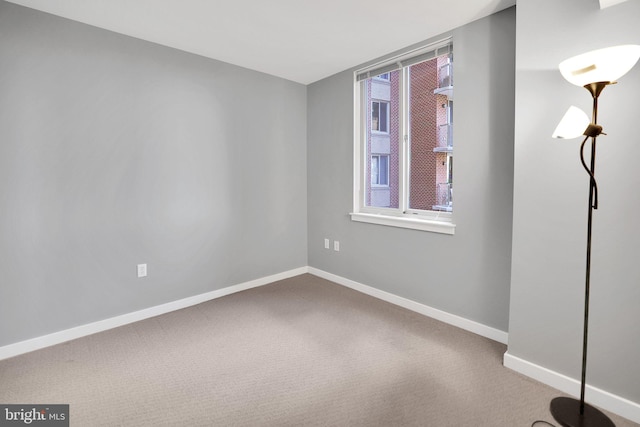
[0,1,307,346]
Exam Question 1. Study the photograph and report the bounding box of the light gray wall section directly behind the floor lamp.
[508,0,640,402]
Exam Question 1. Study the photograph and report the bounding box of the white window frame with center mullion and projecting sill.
[350,38,455,234]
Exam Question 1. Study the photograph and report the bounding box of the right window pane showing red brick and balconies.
[408,56,453,211]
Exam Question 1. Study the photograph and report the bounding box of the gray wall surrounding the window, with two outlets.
[307,8,515,331]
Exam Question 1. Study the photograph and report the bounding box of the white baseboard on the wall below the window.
[309,267,508,344]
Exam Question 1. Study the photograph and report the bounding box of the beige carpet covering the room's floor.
[0,275,638,427]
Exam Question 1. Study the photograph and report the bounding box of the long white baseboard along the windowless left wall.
[0,267,308,360]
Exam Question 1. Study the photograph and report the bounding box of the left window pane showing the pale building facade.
[363,71,400,208]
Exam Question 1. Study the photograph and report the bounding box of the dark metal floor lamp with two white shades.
[550,45,640,427]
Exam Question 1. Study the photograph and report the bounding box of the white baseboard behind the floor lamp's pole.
[503,351,640,423]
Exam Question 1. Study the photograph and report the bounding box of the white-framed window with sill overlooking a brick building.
[351,40,455,234]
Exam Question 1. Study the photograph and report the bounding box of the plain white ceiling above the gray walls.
[8,0,516,84]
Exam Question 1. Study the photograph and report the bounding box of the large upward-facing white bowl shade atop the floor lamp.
[558,44,640,86]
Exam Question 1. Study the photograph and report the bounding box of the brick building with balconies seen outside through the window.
[362,48,453,212]
